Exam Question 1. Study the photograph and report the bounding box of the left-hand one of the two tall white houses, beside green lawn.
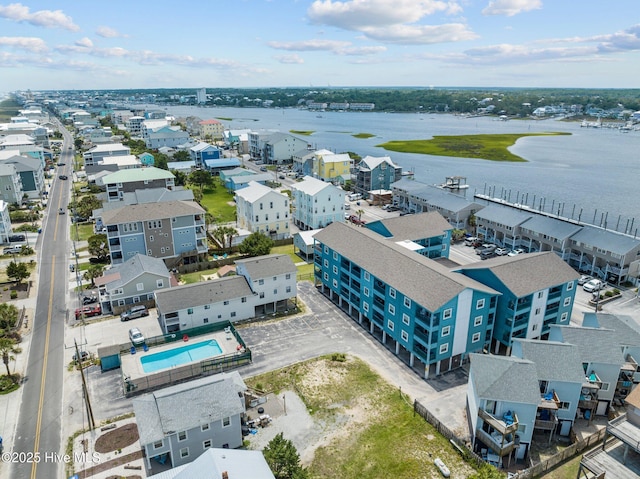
[236,181,290,239]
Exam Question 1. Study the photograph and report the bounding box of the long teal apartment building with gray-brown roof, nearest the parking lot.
[314,218,500,378]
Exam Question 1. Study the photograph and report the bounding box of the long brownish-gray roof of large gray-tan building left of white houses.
[102,201,204,225]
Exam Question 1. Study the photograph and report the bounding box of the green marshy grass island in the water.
[376,132,570,161]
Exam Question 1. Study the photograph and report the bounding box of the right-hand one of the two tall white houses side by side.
[291,176,345,230]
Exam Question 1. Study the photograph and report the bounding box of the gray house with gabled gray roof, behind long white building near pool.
[95,254,172,314]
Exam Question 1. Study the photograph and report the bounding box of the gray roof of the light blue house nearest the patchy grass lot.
[469,354,540,405]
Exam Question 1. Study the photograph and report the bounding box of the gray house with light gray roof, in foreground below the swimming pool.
[133,372,247,477]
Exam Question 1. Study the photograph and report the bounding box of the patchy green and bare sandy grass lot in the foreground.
[246,354,474,479]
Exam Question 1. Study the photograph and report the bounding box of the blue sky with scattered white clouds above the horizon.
[0,0,640,92]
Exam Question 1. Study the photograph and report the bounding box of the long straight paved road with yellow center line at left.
[10,124,73,479]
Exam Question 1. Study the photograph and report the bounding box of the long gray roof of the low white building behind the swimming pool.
[156,276,253,314]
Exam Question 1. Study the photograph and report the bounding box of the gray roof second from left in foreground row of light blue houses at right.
[514,339,584,384]
